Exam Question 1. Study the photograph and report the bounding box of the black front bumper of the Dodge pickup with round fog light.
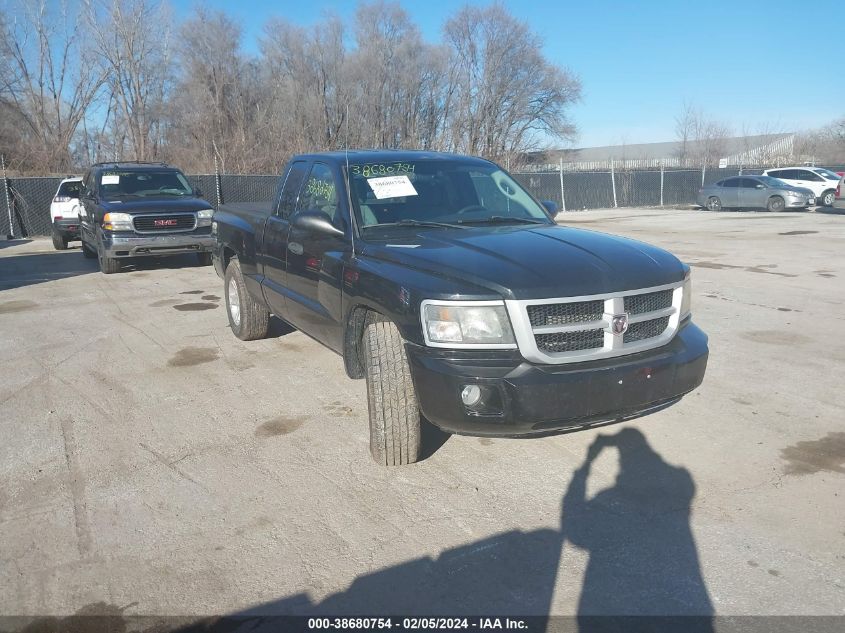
[407,322,708,437]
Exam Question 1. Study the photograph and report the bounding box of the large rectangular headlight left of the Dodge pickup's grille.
[422,301,516,348]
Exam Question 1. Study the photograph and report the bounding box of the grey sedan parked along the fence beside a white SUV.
[697,176,816,211]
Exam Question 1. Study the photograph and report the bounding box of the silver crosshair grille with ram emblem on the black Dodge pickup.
[505,281,683,365]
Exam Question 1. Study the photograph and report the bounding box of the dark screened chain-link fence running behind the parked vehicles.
[0,165,845,238]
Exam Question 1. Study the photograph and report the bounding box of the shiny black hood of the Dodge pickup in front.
[362,226,685,299]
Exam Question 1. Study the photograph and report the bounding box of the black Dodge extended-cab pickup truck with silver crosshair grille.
[212,151,708,465]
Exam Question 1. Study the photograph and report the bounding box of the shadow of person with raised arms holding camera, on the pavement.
[561,428,713,631]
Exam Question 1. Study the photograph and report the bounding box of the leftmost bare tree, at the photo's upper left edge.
[0,0,104,172]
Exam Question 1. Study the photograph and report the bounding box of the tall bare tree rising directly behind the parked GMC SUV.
[85,0,172,160]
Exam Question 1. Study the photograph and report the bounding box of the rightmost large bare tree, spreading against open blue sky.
[444,4,581,159]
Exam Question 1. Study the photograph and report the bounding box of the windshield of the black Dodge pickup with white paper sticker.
[349,160,551,229]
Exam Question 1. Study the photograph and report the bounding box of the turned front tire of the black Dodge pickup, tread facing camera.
[363,321,422,466]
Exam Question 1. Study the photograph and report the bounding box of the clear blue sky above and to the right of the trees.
[172,0,845,146]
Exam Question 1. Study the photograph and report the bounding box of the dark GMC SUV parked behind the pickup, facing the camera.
[80,161,214,275]
